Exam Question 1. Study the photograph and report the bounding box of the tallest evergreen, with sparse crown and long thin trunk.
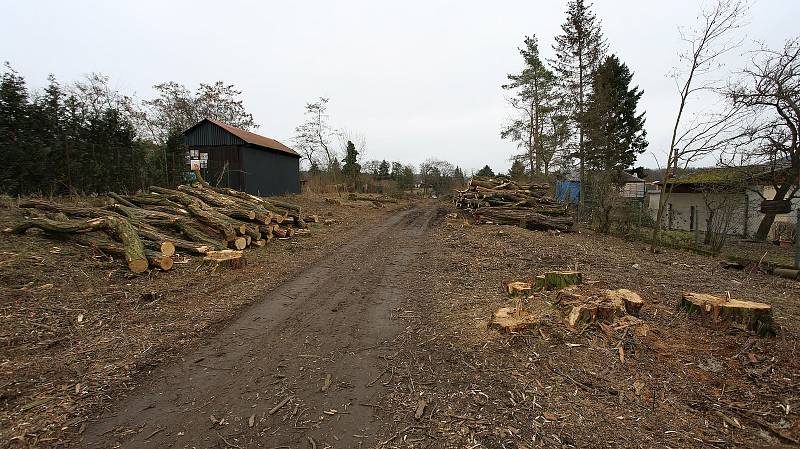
[551,0,606,204]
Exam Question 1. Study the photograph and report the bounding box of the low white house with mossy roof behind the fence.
[647,167,800,237]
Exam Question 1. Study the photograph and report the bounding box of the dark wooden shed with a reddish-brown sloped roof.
[183,119,300,196]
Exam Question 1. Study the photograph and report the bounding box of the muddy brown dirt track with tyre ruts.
[80,204,438,448]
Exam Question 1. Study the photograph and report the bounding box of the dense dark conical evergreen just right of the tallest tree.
[581,55,647,172]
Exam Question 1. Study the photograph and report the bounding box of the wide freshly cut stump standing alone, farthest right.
[678,292,777,337]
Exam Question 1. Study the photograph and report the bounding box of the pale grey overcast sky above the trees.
[0,0,800,172]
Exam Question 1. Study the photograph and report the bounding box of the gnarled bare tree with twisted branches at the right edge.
[727,38,800,240]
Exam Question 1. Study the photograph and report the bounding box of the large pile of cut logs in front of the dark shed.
[6,183,319,273]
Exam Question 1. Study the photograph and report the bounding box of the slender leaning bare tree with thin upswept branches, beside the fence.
[652,0,747,249]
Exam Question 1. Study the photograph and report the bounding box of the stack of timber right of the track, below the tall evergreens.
[454,176,575,232]
